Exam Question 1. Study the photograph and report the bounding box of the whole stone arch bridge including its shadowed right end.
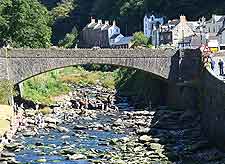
[0,48,201,84]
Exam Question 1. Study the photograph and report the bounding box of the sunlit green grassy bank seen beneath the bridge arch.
[23,67,117,104]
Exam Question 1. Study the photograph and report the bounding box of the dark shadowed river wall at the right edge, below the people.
[202,68,225,150]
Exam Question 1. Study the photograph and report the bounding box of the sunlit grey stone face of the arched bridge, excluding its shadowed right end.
[0,49,178,83]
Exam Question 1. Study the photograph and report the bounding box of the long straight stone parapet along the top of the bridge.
[0,48,177,58]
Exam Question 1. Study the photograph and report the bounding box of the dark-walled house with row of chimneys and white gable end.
[79,18,133,48]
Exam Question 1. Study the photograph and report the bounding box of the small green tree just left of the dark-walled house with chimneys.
[59,27,78,48]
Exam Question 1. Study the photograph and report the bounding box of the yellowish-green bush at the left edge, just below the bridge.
[0,80,14,105]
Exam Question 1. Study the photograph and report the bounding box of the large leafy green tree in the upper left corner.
[0,0,52,48]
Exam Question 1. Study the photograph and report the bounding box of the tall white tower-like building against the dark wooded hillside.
[144,14,164,38]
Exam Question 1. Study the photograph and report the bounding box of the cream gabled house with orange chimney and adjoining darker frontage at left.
[152,15,201,48]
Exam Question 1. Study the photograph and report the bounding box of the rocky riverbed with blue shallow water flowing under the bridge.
[0,86,225,164]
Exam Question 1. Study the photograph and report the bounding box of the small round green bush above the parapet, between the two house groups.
[132,32,149,46]
